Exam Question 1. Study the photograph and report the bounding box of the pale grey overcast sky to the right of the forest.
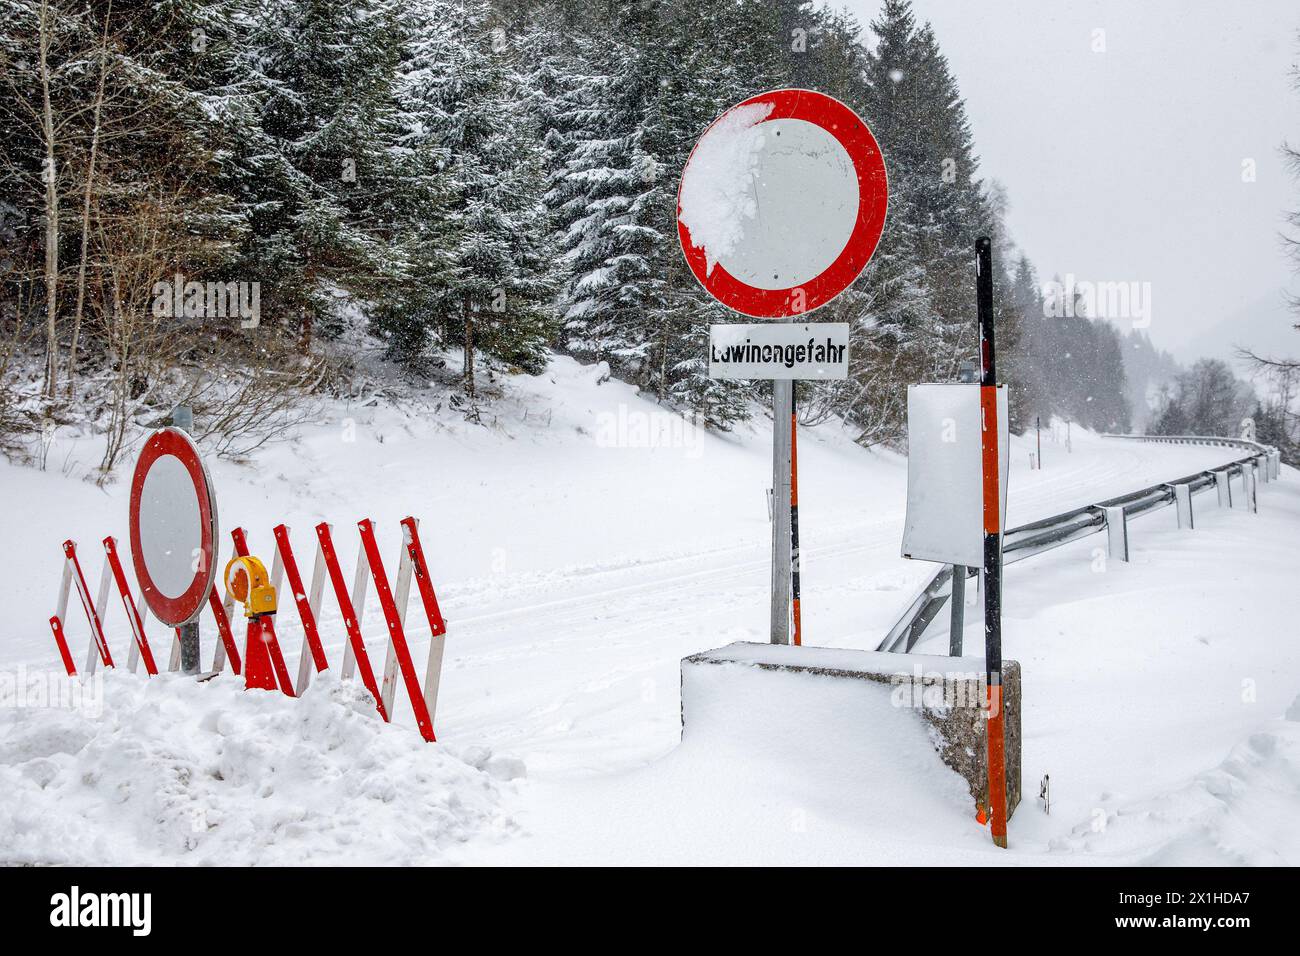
[846,0,1300,359]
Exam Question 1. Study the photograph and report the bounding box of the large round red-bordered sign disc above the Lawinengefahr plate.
[677,90,889,319]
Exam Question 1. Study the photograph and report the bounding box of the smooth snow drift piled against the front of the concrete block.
[488,649,988,865]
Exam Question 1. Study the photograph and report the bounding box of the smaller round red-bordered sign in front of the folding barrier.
[130,428,217,627]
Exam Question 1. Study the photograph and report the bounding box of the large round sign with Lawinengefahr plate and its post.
[677,90,889,644]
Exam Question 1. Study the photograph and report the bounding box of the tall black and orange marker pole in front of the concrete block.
[975,235,1006,847]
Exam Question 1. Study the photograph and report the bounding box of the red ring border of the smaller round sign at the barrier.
[130,428,217,627]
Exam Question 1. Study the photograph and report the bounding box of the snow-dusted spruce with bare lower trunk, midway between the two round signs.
[402,0,554,397]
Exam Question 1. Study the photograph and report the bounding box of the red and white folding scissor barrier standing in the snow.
[49,518,447,741]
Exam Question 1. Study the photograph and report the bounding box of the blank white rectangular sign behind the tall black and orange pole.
[902,384,1010,567]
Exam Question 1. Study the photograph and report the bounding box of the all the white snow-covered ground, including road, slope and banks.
[0,359,1300,864]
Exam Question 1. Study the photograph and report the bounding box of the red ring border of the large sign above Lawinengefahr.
[677,90,889,319]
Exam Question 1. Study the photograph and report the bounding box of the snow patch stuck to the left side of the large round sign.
[680,103,774,276]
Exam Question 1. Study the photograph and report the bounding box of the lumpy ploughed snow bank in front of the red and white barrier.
[0,674,523,865]
